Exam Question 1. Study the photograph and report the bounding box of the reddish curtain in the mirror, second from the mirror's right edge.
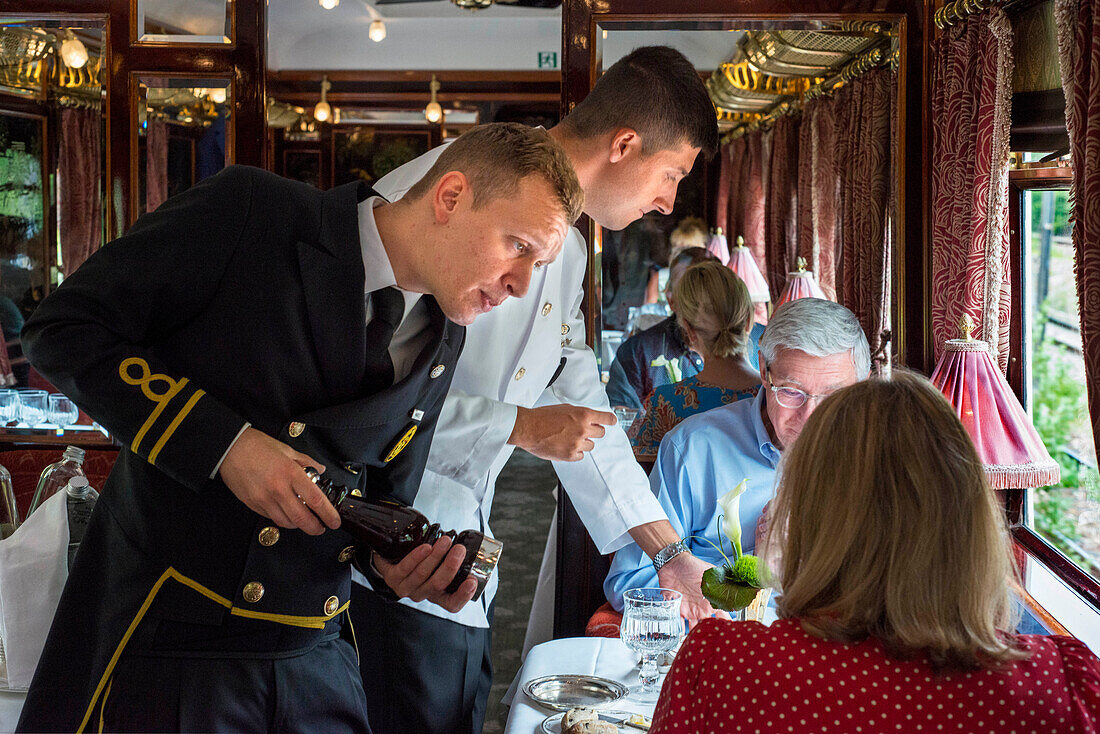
[798,98,839,300]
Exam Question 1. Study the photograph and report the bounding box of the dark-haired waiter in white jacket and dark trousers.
[351,46,718,734]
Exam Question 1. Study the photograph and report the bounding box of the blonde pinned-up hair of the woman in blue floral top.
[672,260,752,358]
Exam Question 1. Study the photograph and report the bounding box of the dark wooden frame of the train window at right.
[1004,166,1100,616]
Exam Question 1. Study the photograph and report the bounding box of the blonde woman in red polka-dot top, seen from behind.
[652,372,1100,734]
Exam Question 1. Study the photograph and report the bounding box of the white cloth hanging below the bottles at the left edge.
[0,492,68,689]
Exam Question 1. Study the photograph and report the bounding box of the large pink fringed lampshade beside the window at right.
[932,325,1062,490]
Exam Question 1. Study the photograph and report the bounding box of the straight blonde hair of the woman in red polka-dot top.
[766,370,1026,669]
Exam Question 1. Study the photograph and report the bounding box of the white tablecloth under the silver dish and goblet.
[504,637,664,734]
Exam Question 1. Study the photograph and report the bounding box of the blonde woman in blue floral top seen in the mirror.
[630,262,760,460]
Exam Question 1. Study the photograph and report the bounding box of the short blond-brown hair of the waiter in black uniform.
[407,122,584,224]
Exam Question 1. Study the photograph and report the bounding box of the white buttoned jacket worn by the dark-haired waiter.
[356,146,667,627]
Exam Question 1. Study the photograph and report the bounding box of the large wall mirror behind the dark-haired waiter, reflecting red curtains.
[589,15,905,389]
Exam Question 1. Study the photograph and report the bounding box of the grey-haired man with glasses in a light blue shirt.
[604,298,871,611]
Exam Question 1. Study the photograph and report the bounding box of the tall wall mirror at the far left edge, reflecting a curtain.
[0,17,106,385]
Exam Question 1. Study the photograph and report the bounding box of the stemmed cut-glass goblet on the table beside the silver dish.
[619,589,684,703]
